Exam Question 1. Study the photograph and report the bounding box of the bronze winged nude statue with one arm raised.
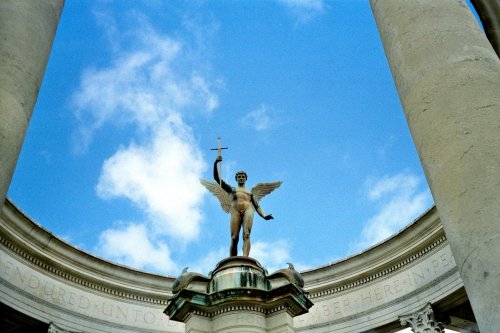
[200,155,282,257]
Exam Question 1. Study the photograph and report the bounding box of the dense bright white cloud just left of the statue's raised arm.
[97,118,205,240]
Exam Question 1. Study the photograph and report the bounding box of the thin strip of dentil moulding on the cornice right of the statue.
[308,234,446,299]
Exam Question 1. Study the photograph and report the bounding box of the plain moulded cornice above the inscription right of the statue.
[302,207,448,299]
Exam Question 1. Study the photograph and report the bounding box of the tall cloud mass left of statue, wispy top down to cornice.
[72,14,218,273]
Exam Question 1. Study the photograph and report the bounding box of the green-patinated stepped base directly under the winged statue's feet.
[164,256,313,322]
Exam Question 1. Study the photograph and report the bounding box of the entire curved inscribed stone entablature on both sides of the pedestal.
[0,201,463,332]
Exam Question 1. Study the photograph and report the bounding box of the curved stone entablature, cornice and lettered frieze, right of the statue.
[295,209,462,332]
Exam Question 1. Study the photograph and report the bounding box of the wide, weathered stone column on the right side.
[370,0,500,333]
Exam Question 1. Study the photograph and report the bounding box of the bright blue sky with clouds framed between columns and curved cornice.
[8,0,442,275]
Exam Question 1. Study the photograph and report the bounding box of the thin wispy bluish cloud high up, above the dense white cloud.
[73,25,218,152]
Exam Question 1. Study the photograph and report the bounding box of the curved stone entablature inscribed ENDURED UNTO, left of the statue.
[0,202,184,332]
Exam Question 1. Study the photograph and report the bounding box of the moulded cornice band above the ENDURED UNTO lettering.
[0,200,174,306]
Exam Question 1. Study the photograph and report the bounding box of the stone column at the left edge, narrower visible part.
[0,0,64,205]
